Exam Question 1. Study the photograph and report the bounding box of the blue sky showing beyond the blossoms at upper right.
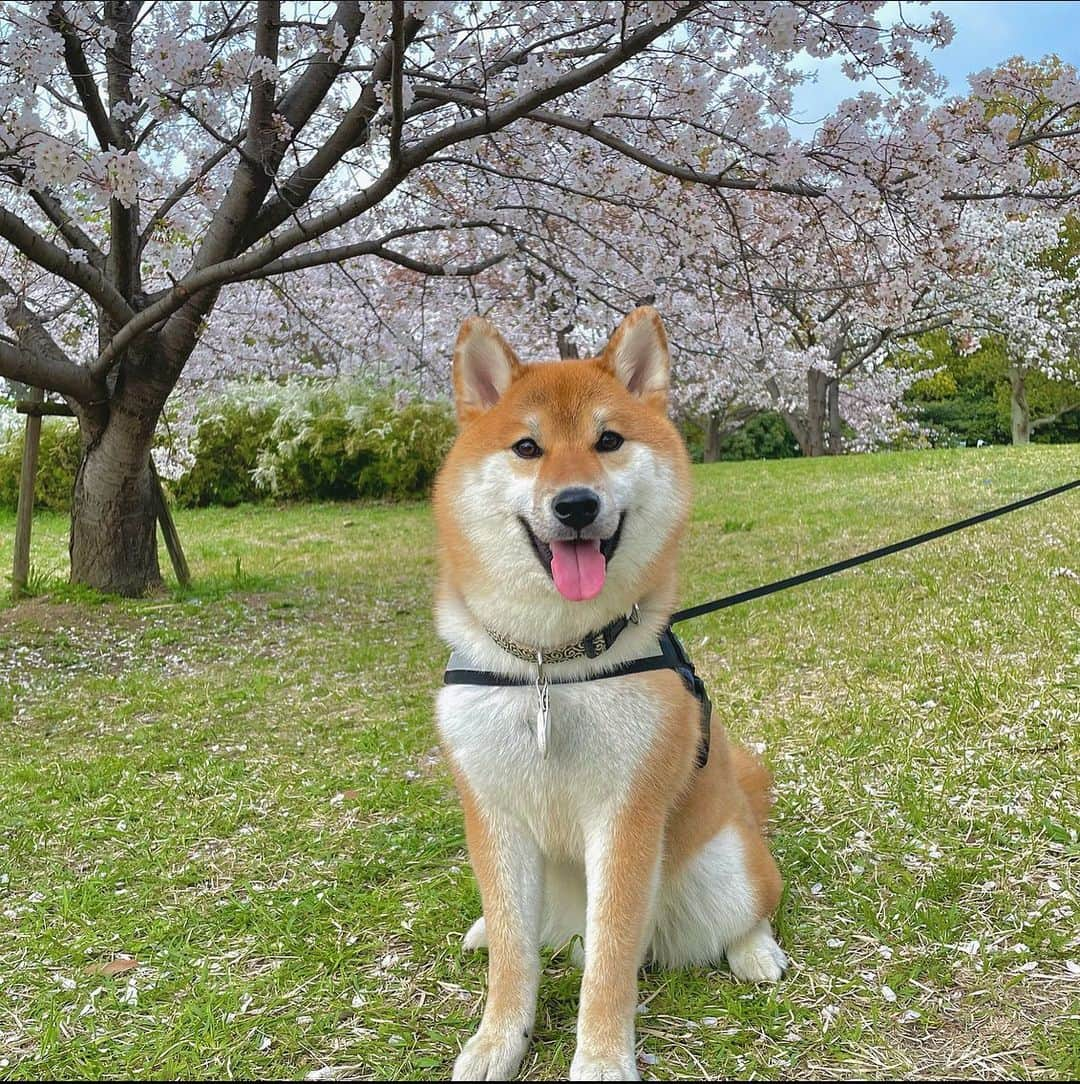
[796,0,1080,121]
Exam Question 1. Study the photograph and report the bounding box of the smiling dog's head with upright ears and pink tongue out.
[436,308,690,629]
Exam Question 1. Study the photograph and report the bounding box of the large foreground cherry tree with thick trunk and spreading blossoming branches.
[0,0,1080,594]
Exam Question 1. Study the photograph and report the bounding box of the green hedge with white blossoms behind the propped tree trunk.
[0,380,454,512]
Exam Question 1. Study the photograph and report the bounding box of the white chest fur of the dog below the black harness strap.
[438,676,659,862]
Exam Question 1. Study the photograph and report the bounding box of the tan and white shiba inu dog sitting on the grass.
[435,308,786,1080]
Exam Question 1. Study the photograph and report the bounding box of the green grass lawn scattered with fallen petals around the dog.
[0,446,1080,1080]
